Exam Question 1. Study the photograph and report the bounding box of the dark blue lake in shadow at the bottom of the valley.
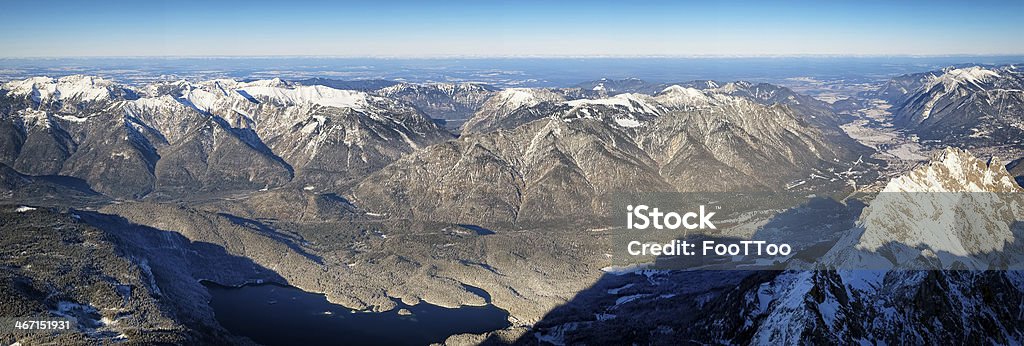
[203,282,509,345]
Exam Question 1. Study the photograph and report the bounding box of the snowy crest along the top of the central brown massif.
[463,80,840,133]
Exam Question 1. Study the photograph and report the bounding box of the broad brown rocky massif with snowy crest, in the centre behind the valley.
[353,86,861,225]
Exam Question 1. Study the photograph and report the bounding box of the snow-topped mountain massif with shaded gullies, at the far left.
[0,76,451,198]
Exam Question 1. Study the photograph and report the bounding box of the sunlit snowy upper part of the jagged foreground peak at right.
[835,148,1024,268]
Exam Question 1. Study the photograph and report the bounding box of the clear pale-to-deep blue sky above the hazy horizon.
[0,0,1024,57]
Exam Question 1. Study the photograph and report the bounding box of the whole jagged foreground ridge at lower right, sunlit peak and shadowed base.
[741,148,1024,344]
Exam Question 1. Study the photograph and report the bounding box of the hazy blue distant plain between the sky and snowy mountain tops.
[6,55,1024,87]
